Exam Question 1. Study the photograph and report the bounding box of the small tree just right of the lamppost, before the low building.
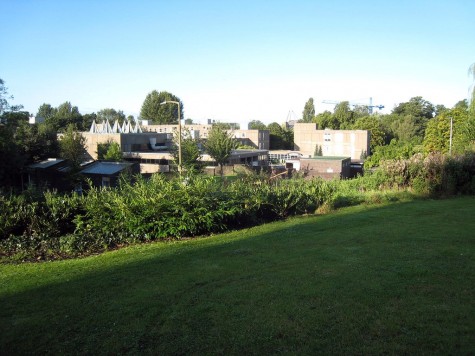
[205,125,238,176]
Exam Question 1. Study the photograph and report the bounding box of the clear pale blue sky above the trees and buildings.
[0,0,475,125]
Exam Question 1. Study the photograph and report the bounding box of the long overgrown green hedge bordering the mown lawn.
[0,154,475,260]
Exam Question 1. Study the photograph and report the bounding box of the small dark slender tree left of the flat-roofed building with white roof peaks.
[59,124,86,182]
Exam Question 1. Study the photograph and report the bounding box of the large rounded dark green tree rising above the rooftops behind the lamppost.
[140,90,183,125]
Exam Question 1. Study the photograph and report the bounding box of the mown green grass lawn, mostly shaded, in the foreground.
[0,197,475,355]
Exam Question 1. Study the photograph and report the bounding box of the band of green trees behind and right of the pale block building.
[300,89,475,166]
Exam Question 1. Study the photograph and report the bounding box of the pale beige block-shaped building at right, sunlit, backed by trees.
[294,123,370,160]
